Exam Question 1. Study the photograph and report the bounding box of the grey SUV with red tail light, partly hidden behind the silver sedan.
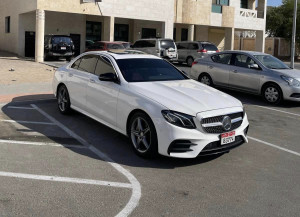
[176,41,219,67]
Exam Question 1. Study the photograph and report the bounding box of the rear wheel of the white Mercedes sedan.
[57,85,71,115]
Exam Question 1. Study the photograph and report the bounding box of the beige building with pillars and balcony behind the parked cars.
[0,0,267,61]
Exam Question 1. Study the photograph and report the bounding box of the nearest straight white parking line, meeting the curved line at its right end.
[0,171,132,188]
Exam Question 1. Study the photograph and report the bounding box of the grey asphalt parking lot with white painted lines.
[0,80,300,216]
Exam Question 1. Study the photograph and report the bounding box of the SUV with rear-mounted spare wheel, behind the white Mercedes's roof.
[132,38,178,61]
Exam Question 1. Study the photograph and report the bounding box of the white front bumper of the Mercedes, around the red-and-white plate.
[155,107,249,158]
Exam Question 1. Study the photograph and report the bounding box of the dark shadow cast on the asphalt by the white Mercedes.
[0,96,222,169]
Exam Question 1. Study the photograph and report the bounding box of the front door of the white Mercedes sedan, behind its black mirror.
[87,56,120,126]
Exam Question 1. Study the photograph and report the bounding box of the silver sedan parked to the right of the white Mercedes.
[190,51,300,104]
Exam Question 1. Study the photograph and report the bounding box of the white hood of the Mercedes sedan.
[129,80,242,116]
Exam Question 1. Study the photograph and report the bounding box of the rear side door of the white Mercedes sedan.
[67,55,98,110]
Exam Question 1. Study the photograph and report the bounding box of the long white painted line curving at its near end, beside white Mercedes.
[31,104,142,217]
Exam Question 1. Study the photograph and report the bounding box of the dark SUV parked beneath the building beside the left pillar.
[44,35,75,61]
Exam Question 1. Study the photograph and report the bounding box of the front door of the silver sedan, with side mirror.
[229,54,262,93]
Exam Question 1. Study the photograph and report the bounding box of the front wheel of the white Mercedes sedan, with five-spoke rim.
[128,112,158,158]
